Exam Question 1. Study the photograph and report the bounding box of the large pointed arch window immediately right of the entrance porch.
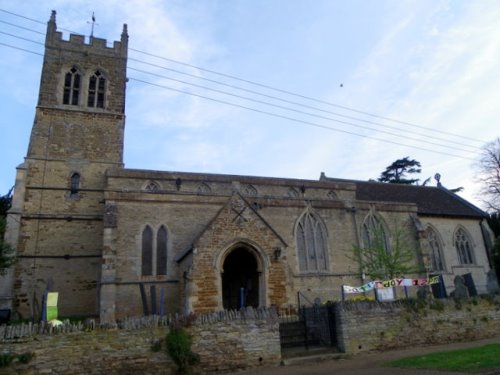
[296,211,328,271]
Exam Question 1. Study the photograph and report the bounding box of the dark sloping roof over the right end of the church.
[356,181,486,219]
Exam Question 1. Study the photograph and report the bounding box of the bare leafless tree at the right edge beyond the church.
[478,138,500,212]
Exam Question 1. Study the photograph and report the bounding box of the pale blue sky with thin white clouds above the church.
[0,0,500,206]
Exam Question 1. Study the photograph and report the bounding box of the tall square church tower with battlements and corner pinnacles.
[7,11,128,318]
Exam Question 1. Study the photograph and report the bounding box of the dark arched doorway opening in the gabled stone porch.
[221,246,260,310]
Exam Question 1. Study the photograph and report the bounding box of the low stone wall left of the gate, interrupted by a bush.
[0,308,281,375]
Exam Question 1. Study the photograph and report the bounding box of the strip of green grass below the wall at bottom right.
[385,344,500,373]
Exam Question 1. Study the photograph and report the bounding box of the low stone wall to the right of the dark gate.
[336,298,500,353]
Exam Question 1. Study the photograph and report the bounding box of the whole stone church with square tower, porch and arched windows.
[0,12,491,322]
